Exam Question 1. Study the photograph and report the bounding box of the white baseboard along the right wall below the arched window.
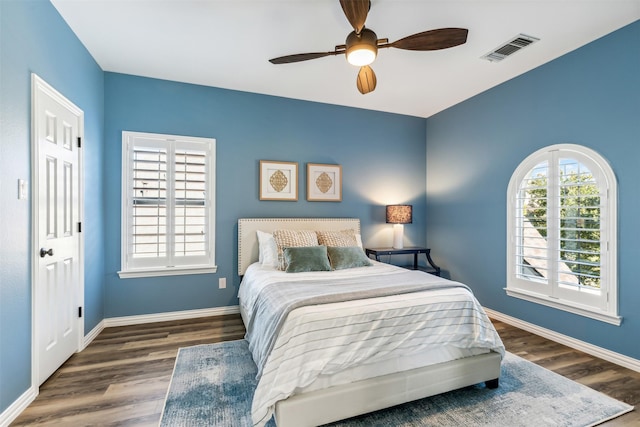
[484,308,640,372]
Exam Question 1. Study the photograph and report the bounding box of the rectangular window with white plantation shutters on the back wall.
[118,131,216,277]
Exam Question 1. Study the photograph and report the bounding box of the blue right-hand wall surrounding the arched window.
[427,22,640,359]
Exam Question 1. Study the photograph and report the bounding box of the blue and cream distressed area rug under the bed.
[160,340,633,427]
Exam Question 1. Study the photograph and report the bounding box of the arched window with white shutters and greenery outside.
[506,144,621,325]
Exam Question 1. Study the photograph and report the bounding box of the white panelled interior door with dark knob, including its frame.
[32,75,84,385]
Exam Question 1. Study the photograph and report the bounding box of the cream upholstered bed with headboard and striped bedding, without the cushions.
[238,218,504,427]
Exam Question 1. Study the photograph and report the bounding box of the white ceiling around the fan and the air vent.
[51,0,640,117]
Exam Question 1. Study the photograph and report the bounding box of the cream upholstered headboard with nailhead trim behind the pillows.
[238,218,360,276]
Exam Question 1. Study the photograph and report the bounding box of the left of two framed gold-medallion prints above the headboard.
[260,160,298,202]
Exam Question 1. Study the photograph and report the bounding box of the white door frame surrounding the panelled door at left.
[31,73,84,394]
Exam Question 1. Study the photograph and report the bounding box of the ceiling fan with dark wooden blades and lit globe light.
[269,0,469,95]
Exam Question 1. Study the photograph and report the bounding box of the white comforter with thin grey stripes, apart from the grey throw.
[238,263,504,426]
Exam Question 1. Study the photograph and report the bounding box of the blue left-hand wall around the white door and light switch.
[0,0,104,412]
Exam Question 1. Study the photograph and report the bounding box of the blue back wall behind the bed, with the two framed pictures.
[105,73,426,317]
